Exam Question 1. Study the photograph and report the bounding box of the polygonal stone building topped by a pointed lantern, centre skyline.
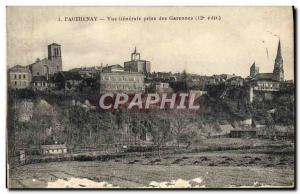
[124,48,151,73]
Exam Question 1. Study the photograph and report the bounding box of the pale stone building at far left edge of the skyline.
[8,65,31,89]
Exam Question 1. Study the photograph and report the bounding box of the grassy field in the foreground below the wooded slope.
[9,150,294,188]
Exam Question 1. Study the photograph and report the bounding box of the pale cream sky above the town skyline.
[7,7,294,79]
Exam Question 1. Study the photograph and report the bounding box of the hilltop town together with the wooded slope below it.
[8,41,294,174]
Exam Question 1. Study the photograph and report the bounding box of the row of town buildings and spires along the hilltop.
[8,41,293,95]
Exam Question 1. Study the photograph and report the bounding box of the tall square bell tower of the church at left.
[48,43,62,71]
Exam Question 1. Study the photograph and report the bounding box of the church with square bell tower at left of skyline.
[29,43,62,79]
